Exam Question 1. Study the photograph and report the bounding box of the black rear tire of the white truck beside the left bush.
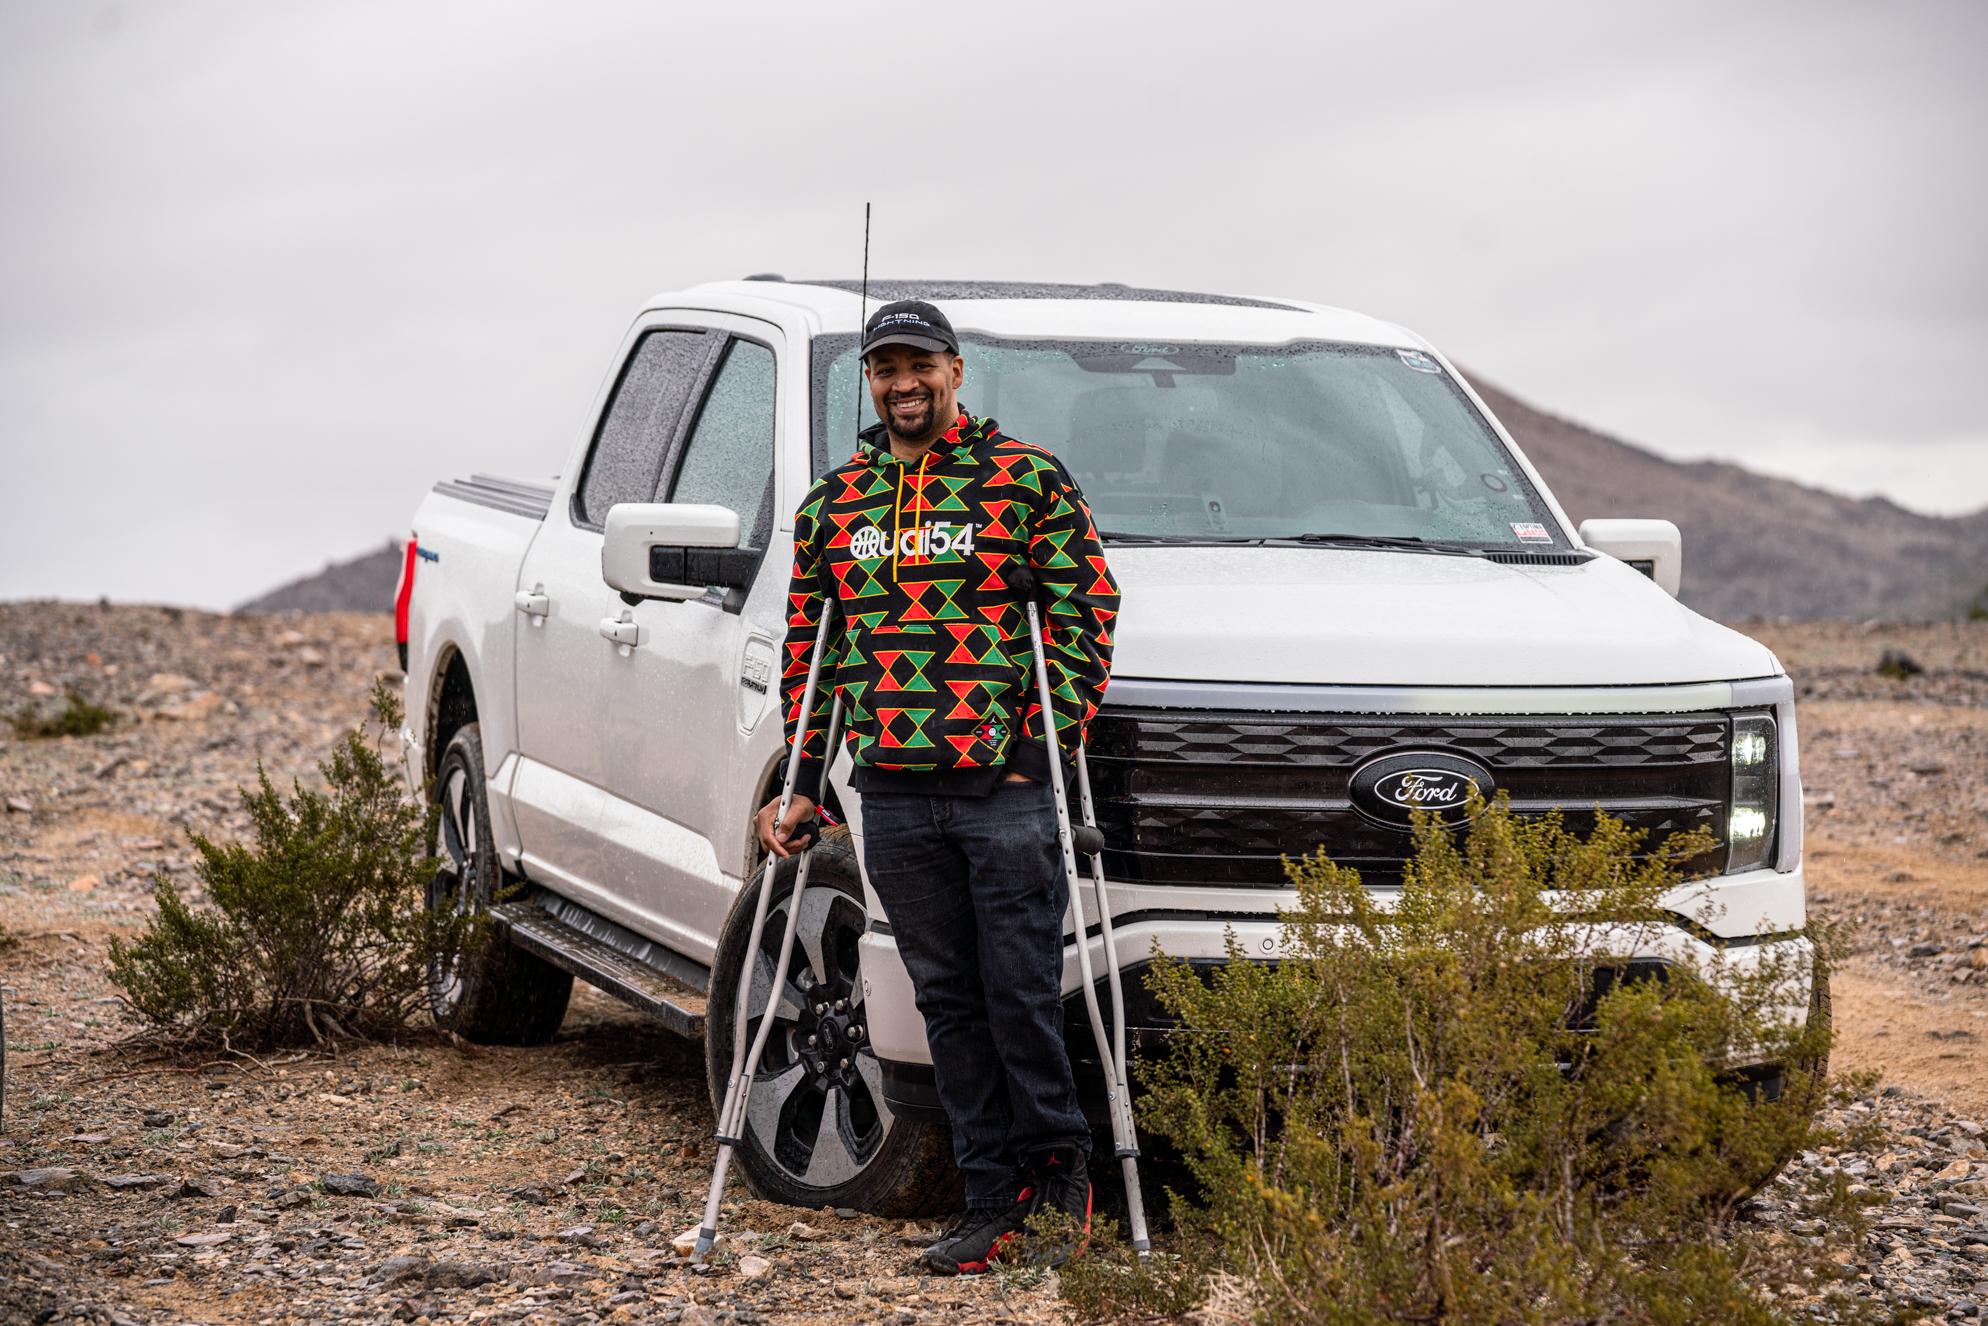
[427,724,573,1046]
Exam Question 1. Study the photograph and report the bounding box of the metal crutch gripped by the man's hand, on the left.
[690,598,843,1262]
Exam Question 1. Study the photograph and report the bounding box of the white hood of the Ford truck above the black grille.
[1105,545,1781,686]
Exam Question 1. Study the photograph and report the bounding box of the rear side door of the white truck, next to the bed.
[511,324,724,909]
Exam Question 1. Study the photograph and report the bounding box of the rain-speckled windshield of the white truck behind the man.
[815,334,1565,549]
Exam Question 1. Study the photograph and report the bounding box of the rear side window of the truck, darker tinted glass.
[573,330,712,529]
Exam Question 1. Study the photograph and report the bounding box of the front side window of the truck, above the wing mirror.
[666,340,773,549]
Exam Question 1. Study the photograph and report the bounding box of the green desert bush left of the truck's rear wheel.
[109,686,483,1048]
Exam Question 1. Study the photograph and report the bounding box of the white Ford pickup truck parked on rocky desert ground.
[396,276,1823,1213]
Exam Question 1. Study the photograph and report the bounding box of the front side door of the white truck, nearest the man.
[602,314,787,962]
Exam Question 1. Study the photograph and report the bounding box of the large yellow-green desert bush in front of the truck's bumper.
[1064,799,1859,1324]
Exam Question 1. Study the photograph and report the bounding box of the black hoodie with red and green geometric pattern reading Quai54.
[779,414,1117,795]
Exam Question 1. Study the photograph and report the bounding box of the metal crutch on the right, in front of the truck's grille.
[1004,561,1153,1256]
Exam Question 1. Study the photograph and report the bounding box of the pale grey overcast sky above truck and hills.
[0,0,1988,606]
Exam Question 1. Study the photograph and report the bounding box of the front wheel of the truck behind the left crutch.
[704,827,960,1217]
